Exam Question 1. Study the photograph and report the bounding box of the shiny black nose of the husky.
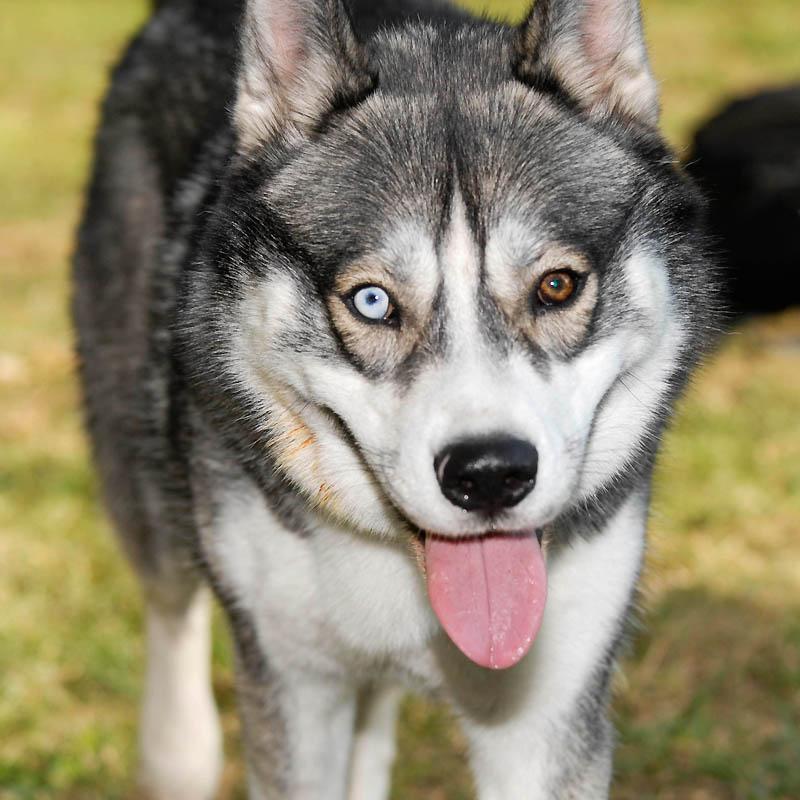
[433,437,539,513]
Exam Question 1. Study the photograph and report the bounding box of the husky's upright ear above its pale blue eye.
[234,0,376,152]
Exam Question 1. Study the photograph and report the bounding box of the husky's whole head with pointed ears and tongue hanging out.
[184,0,713,666]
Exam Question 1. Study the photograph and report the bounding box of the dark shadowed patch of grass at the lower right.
[613,587,800,800]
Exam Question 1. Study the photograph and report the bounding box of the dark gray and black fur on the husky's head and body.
[73,0,716,800]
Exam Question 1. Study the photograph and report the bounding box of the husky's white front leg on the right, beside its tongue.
[442,496,647,800]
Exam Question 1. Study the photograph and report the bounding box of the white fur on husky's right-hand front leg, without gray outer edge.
[450,490,647,800]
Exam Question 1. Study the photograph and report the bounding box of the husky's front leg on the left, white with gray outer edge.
[193,440,358,800]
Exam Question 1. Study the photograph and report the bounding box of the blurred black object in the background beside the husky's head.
[686,86,800,313]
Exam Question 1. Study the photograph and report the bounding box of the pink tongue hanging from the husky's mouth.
[425,534,547,669]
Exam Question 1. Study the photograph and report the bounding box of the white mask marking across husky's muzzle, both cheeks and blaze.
[234,194,681,536]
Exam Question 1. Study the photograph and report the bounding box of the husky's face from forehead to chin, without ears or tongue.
[239,95,681,535]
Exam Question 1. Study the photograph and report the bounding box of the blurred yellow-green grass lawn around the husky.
[0,0,800,800]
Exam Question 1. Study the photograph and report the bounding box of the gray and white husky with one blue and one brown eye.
[74,0,716,800]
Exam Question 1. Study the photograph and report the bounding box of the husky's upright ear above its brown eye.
[516,0,659,127]
